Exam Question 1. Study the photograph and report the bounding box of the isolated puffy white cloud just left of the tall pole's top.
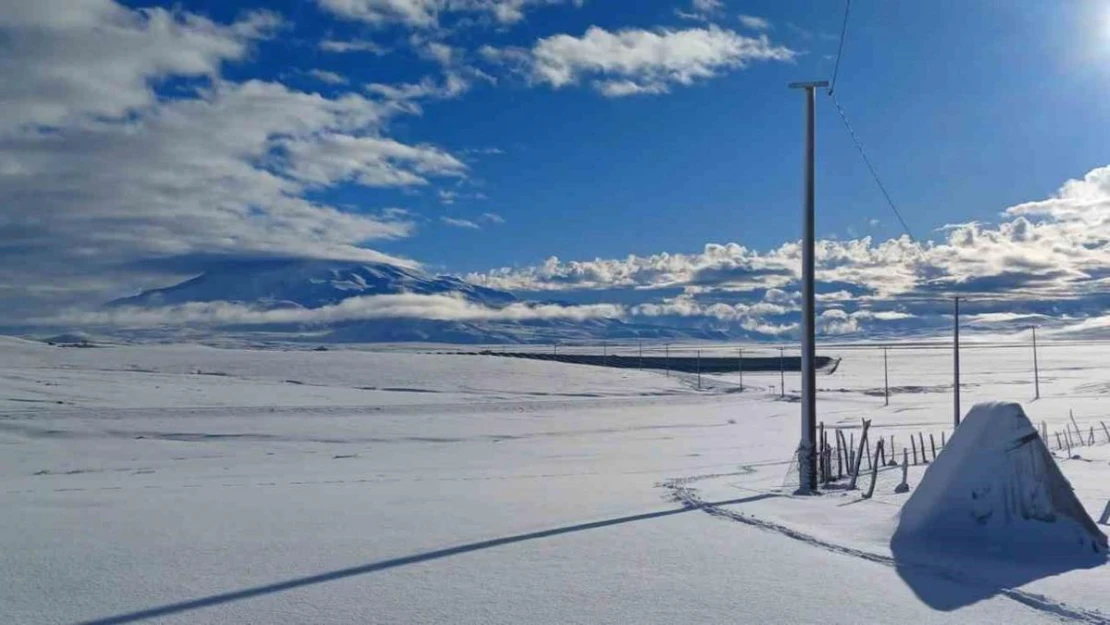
[512,26,796,97]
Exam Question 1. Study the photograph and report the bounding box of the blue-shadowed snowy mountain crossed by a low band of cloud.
[108,261,729,344]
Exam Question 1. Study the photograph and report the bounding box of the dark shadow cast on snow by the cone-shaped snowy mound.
[890,532,1107,612]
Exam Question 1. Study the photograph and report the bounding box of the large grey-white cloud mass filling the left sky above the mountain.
[0,0,466,316]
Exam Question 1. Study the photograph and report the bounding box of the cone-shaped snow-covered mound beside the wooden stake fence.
[895,403,1107,560]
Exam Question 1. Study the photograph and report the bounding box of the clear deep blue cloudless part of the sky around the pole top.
[132,0,1110,271]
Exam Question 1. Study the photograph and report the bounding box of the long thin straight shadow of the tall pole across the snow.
[80,495,776,625]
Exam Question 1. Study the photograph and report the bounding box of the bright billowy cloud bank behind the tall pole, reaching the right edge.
[471,167,1110,321]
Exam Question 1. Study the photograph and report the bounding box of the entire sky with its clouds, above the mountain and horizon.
[0,0,1110,332]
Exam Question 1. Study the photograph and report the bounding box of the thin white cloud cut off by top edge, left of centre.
[316,0,583,29]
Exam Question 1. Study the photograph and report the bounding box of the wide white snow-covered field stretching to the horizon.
[0,339,1110,624]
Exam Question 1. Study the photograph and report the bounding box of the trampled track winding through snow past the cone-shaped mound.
[659,475,1110,625]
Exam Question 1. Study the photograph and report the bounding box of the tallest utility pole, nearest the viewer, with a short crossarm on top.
[789,80,829,494]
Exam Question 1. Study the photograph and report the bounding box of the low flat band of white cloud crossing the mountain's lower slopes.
[33,293,625,329]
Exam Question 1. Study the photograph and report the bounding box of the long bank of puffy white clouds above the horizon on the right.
[468,167,1110,334]
